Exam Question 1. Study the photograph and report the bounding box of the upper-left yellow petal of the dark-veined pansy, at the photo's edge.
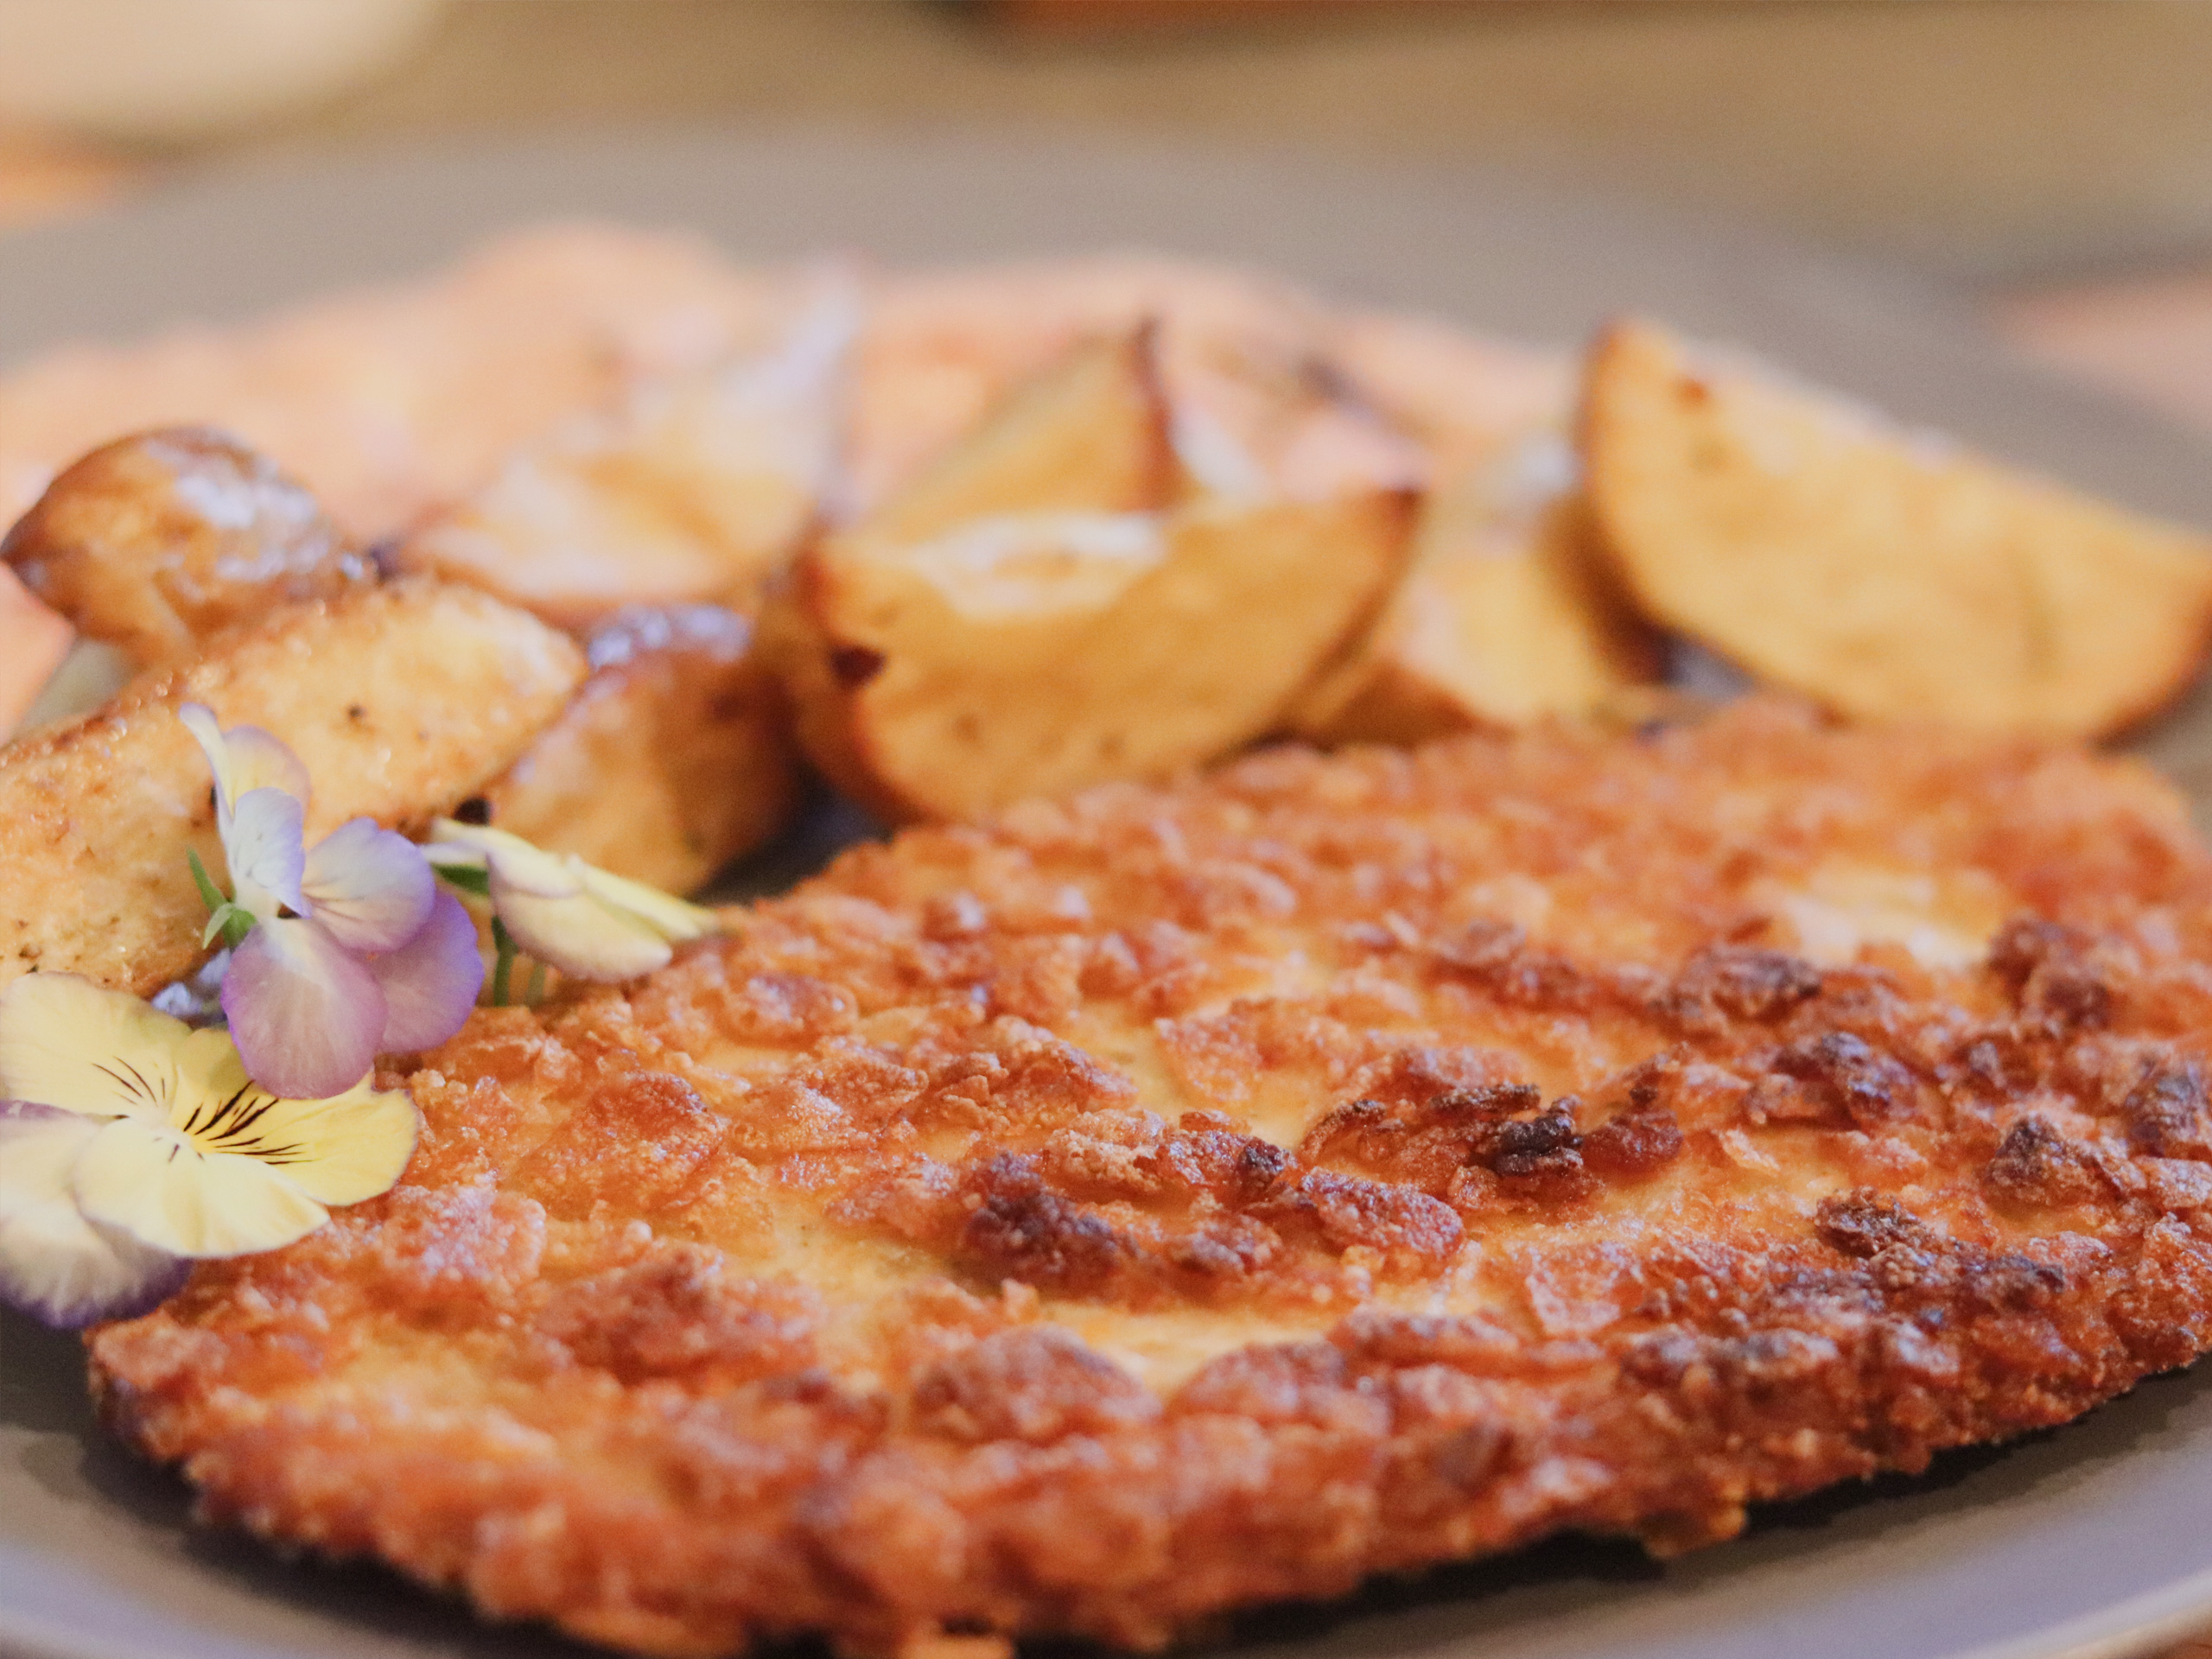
[0,973,188,1117]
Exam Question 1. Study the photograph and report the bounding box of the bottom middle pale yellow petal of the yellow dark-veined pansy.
[73,1117,329,1259]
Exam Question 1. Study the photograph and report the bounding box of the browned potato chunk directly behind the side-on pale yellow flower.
[485,606,798,893]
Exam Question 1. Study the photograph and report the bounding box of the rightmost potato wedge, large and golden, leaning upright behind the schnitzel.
[1581,323,2212,736]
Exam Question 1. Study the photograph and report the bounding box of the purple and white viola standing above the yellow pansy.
[179,703,485,1099]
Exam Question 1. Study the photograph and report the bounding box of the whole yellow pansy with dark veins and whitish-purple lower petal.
[0,973,416,1327]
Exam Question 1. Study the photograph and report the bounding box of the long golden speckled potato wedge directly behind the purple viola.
[0,582,584,995]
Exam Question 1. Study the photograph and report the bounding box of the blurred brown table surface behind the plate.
[0,0,2212,1659]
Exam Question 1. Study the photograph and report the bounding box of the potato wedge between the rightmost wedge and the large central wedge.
[1287,427,1659,743]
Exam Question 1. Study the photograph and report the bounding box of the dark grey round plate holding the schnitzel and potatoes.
[0,135,2212,1659]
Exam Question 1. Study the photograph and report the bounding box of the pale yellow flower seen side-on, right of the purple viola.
[429,818,721,991]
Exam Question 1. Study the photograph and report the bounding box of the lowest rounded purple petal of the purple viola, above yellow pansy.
[224,918,387,1099]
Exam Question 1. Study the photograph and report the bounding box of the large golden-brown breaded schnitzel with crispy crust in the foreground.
[91,702,2212,1655]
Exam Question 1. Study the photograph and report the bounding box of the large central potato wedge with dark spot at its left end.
[763,491,1411,818]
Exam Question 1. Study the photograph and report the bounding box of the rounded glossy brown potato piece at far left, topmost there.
[0,427,376,668]
